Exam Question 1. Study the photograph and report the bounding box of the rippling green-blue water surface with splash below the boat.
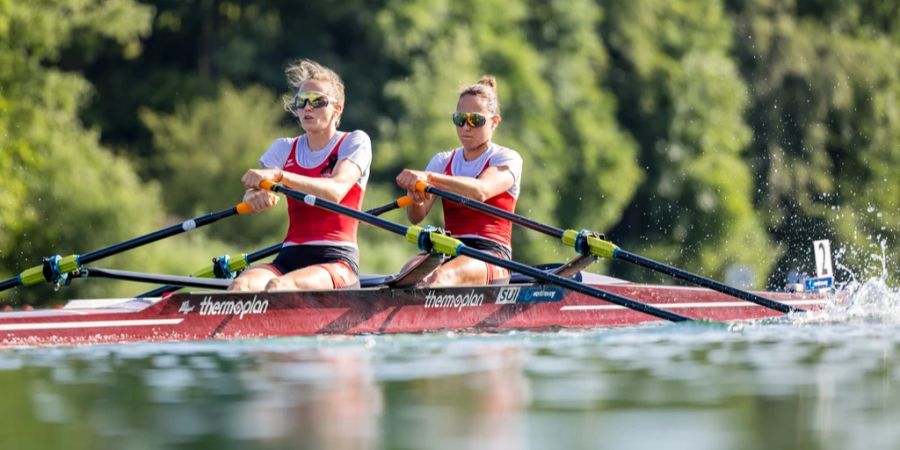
[0,280,900,450]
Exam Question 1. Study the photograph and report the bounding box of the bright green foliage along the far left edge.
[0,1,232,302]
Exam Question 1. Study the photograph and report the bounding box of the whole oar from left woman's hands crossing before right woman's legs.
[260,180,692,322]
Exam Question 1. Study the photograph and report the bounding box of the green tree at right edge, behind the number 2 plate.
[732,0,900,284]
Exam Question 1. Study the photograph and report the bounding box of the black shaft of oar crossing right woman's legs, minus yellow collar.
[261,181,691,322]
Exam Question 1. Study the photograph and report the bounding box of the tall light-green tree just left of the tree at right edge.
[602,0,779,285]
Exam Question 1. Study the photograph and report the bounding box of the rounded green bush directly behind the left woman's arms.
[141,84,292,251]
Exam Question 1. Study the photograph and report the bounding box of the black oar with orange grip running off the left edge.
[0,203,252,291]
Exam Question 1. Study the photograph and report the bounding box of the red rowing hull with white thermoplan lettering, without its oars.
[0,273,828,347]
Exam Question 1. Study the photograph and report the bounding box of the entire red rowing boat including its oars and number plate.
[0,185,833,347]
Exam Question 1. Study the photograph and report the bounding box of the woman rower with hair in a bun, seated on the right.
[397,75,522,286]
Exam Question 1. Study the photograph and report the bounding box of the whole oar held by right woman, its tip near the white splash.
[416,181,803,313]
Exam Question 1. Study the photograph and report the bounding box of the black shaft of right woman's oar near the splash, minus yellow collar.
[416,182,803,313]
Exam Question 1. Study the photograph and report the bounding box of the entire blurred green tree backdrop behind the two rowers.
[0,0,900,303]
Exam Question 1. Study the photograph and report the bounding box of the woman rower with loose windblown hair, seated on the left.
[230,60,372,291]
